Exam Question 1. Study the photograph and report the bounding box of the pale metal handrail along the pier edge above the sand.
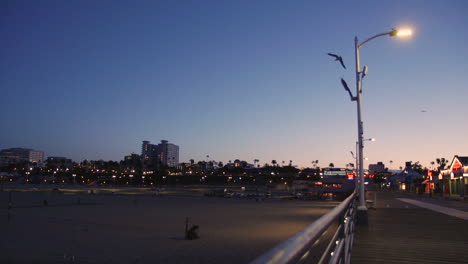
[250,192,356,264]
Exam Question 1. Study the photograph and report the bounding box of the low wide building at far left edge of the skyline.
[0,148,44,167]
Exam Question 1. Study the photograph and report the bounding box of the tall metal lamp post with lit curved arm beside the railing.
[353,29,411,224]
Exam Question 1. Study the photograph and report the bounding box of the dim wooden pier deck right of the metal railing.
[351,191,468,264]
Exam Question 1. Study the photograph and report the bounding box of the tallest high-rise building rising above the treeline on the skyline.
[141,140,179,167]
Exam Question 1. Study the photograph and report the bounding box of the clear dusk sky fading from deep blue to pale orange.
[0,0,468,169]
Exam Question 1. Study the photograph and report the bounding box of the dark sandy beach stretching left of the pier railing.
[0,191,337,263]
